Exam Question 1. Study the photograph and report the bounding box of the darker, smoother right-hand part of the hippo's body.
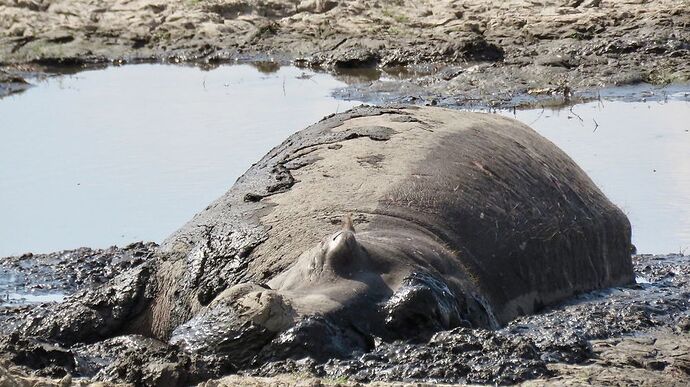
[368,107,634,323]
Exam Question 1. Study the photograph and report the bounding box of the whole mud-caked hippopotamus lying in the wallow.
[2,106,634,367]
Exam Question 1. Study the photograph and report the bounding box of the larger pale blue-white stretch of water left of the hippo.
[0,65,355,256]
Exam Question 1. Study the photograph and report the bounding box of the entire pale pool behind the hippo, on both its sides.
[0,65,690,256]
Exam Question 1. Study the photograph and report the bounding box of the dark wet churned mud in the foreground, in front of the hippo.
[0,253,690,386]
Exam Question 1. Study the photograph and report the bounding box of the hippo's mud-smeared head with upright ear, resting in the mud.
[171,216,476,361]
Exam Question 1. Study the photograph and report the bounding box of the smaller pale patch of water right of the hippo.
[504,98,690,254]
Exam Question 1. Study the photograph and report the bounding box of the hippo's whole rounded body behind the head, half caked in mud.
[163,107,632,334]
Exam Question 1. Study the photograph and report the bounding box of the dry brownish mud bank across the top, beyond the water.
[0,0,690,106]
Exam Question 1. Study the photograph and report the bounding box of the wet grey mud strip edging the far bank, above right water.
[333,72,690,111]
